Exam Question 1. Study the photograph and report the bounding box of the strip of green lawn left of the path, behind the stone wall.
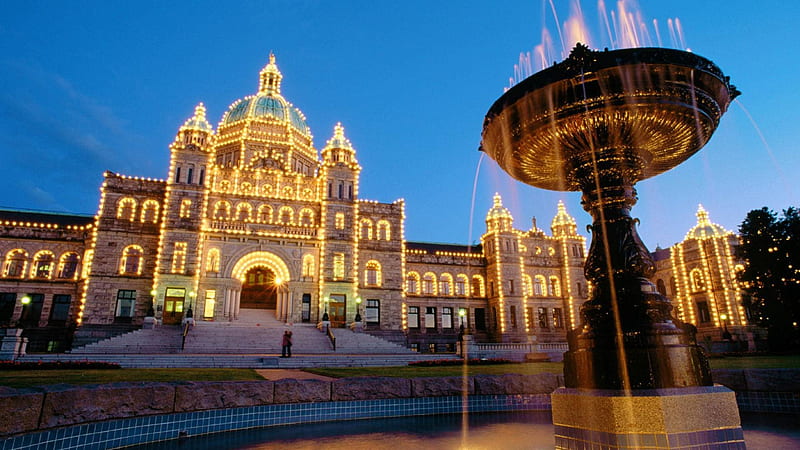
[0,369,264,388]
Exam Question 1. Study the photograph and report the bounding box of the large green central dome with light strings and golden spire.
[220,54,311,137]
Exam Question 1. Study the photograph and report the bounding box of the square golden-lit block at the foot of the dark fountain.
[551,385,745,449]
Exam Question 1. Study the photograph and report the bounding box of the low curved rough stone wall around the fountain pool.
[0,369,800,437]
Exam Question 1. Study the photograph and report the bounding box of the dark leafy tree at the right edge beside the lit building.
[736,207,800,350]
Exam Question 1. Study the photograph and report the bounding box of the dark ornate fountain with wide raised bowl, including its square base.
[481,44,744,447]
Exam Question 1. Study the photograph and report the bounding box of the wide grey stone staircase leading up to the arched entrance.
[22,309,454,368]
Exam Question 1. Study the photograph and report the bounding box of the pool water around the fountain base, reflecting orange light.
[134,412,800,450]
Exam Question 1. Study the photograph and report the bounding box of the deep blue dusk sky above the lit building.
[0,0,800,250]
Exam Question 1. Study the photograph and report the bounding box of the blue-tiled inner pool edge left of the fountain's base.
[0,394,550,450]
